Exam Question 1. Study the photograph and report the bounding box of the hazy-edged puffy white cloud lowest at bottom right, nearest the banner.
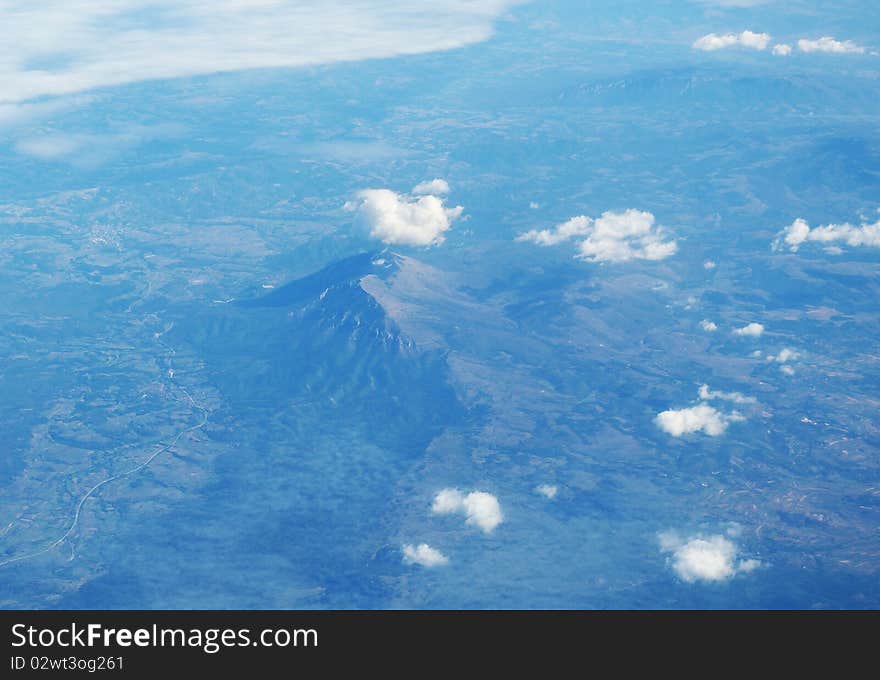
[660,532,761,583]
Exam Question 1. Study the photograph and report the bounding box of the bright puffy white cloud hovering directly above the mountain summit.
[346,186,464,246]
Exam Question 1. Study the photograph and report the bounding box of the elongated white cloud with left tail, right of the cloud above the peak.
[516,208,678,262]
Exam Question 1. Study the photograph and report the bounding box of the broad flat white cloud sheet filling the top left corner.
[0,0,516,103]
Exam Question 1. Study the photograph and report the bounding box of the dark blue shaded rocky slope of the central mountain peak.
[176,252,460,446]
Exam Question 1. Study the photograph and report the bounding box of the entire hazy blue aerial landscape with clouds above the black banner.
[0,0,880,609]
